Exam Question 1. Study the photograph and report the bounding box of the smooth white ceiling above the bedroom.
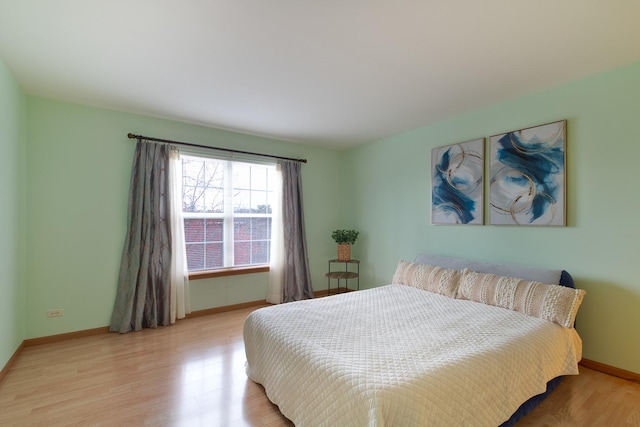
[0,0,640,149]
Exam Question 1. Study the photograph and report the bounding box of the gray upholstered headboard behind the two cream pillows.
[414,253,575,288]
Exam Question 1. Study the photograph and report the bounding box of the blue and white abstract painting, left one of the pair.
[431,138,485,225]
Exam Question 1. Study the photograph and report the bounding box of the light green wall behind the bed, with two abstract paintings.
[343,63,640,373]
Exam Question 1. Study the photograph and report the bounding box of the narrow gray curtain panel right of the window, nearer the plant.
[281,161,313,302]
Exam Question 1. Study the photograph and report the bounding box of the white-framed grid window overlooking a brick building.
[180,155,276,271]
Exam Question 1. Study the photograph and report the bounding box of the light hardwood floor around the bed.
[0,308,640,427]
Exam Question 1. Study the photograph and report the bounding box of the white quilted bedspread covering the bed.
[244,285,582,427]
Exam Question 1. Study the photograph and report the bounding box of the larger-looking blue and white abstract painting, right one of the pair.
[489,120,567,227]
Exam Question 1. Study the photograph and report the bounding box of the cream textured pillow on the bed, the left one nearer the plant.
[391,261,460,298]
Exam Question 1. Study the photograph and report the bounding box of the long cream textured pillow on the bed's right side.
[456,269,586,328]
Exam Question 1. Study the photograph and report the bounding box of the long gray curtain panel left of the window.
[110,140,171,333]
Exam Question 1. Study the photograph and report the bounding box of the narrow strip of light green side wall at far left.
[0,60,26,369]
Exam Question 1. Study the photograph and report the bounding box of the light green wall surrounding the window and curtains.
[26,97,340,338]
